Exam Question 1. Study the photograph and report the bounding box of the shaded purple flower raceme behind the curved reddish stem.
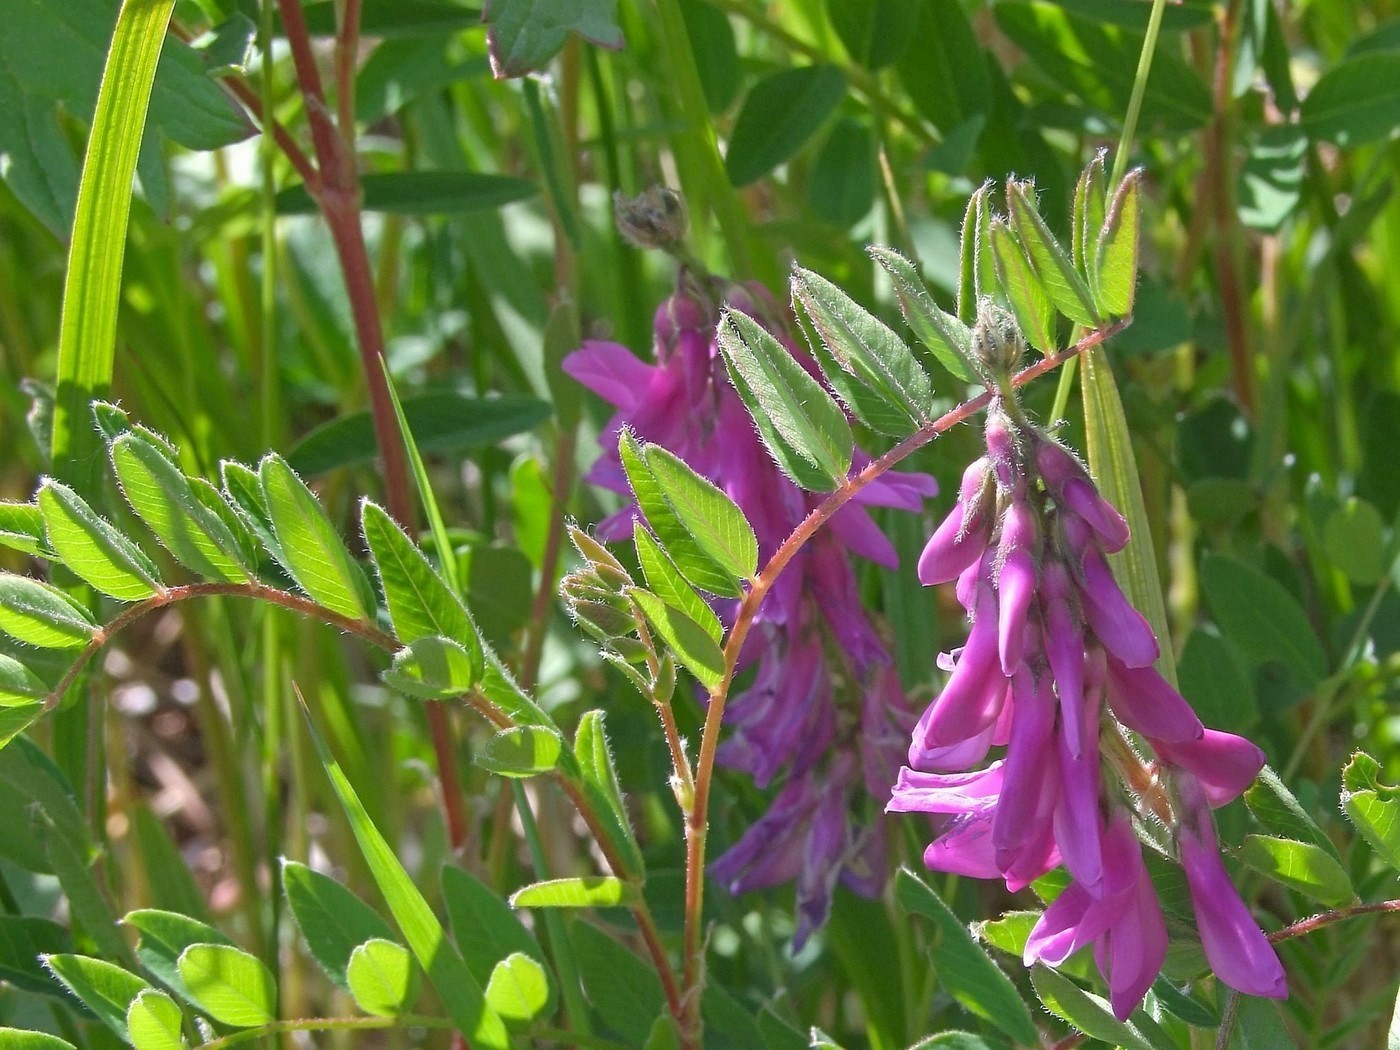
[564,273,935,945]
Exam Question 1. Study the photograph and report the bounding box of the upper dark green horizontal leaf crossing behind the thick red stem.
[276,171,539,218]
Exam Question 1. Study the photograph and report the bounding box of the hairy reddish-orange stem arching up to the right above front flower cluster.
[682,318,1131,1047]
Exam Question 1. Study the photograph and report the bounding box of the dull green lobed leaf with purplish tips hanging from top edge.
[482,0,623,78]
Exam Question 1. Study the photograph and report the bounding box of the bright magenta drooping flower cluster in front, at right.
[889,398,1287,1019]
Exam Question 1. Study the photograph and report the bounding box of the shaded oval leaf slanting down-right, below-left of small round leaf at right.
[1200,554,1327,689]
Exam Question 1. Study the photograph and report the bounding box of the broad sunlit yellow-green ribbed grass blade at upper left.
[52,0,175,493]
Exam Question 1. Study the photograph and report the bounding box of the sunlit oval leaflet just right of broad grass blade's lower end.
[112,433,251,584]
